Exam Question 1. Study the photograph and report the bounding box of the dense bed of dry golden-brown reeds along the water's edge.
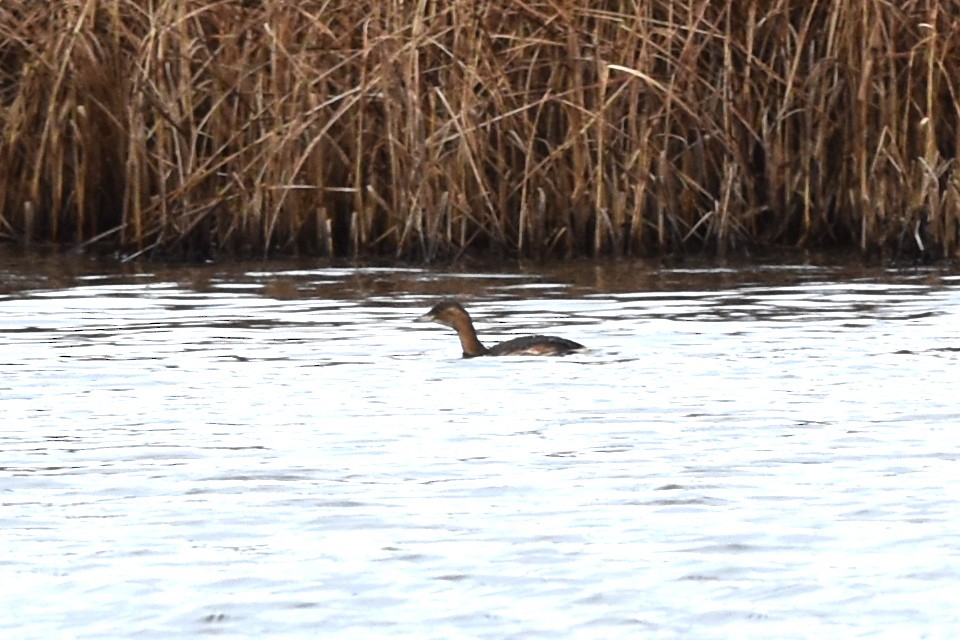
[0,0,960,260]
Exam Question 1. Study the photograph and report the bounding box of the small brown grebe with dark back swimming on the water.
[417,300,586,358]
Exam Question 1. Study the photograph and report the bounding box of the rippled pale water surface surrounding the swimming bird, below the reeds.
[0,255,960,638]
